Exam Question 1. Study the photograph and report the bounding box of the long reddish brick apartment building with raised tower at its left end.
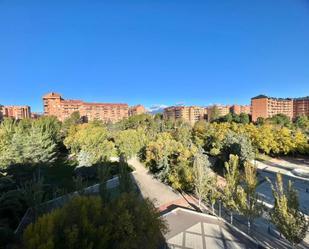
[43,92,129,123]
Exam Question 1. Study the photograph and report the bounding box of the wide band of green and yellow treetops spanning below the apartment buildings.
[0,113,309,171]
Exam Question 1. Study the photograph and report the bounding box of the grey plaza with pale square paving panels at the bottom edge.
[163,208,257,249]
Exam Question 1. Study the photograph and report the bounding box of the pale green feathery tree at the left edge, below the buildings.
[0,118,59,167]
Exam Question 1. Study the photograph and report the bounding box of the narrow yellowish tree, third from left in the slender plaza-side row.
[239,162,263,233]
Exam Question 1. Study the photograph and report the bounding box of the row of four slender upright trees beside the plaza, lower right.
[193,150,309,248]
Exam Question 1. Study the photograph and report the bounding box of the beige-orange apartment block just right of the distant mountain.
[163,106,207,125]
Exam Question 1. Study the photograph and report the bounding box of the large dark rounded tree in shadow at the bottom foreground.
[23,193,167,249]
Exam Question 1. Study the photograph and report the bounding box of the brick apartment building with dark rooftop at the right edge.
[251,95,309,122]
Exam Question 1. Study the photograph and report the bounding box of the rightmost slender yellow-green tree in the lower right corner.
[268,174,309,248]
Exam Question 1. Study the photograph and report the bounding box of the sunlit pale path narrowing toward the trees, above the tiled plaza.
[128,158,181,207]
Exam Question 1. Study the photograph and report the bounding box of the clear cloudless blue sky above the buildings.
[0,0,309,111]
